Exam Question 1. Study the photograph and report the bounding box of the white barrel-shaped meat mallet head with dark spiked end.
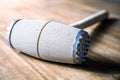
[7,20,89,64]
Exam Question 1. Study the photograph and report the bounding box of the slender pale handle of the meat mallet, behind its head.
[69,10,109,29]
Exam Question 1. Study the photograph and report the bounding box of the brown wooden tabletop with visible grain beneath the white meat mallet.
[0,0,120,80]
